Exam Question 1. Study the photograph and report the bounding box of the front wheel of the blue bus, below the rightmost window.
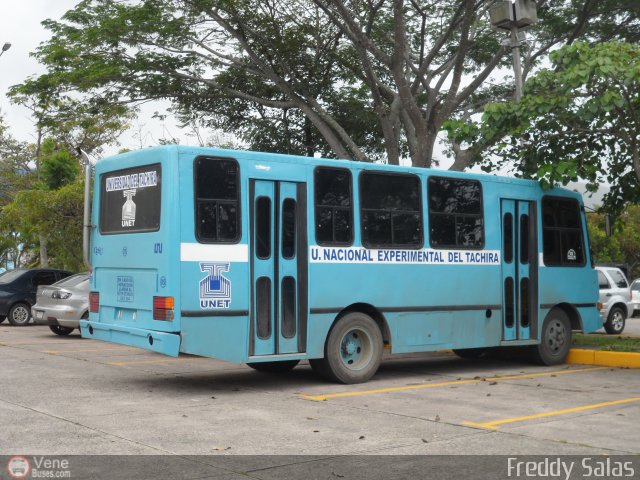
[531,308,571,365]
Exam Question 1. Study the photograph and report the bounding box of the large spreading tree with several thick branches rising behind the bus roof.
[20,0,640,170]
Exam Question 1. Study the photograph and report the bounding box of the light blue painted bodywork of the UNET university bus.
[82,147,601,362]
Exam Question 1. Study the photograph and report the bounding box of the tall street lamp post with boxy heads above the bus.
[489,0,538,101]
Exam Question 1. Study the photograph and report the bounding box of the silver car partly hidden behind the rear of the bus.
[31,273,90,335]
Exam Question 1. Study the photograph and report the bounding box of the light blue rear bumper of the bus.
[80,320,180,357]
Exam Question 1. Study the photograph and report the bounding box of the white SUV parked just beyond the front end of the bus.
[596,267,633,334]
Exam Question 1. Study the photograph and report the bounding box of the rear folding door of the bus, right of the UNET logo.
[249,180,308,356]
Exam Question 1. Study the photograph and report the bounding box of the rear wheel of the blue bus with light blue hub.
[310,312,383,384]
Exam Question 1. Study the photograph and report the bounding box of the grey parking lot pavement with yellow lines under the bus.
[0,324,640,455]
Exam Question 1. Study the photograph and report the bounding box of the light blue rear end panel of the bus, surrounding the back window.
[82,149,181,338]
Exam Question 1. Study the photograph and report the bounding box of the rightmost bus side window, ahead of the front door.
[542,197,585,266]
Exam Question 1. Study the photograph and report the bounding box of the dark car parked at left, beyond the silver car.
[0,268,71,326]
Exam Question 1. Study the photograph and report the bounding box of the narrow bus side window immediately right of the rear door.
[314,167,353,245]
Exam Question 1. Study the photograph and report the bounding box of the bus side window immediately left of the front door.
[428,177,484,249]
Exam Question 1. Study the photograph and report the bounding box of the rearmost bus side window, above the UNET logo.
[194,157,240,243]
